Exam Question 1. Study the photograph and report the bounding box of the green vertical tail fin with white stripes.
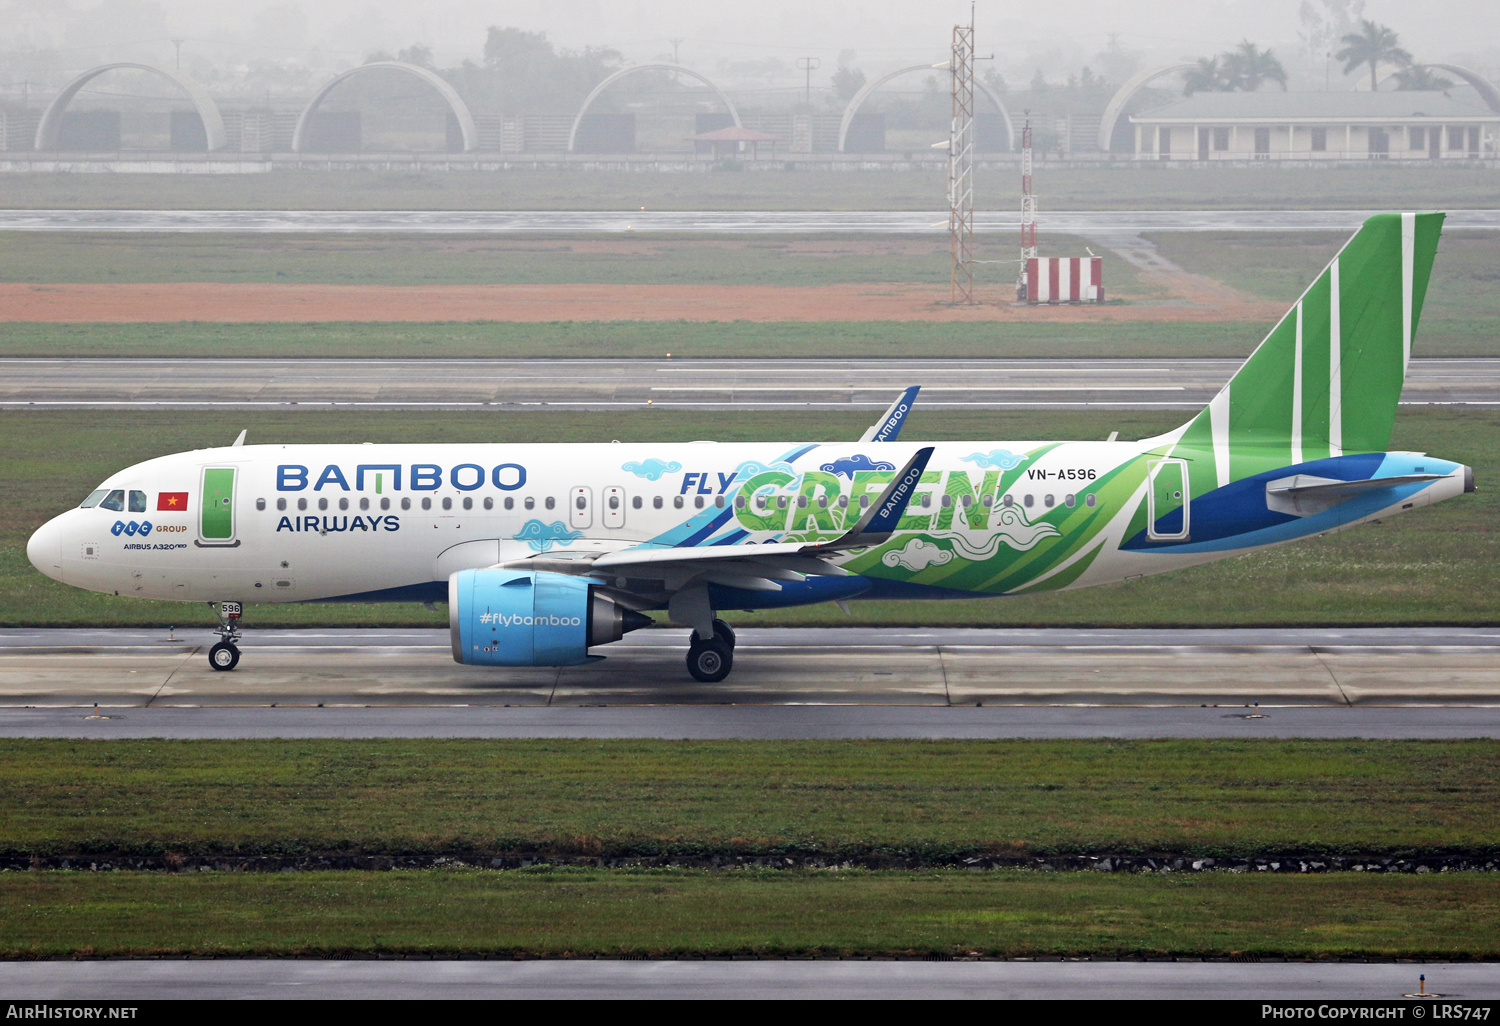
[1176,213,1443,494]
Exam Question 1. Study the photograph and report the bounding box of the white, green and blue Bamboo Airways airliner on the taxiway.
[27,213,1475,683]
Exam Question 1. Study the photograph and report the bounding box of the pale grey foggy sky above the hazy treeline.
[0,0,1500,81]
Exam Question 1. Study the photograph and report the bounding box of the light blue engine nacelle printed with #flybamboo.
[449,569,651,666]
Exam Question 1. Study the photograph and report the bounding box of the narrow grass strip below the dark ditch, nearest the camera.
[0,870,1500,960]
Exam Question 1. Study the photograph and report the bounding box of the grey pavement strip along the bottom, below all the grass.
[0,960,1500,996]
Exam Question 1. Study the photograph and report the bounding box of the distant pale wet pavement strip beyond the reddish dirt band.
[0,210,1500,234]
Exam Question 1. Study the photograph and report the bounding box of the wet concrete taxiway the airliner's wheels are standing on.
[0,629,1500,737]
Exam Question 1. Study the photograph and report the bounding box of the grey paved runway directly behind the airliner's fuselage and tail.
[0,357,1500,411]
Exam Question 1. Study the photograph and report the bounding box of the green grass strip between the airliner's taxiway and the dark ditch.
[0,740,1500,861]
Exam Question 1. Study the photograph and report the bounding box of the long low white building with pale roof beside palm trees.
[1130,92,1500,161]
